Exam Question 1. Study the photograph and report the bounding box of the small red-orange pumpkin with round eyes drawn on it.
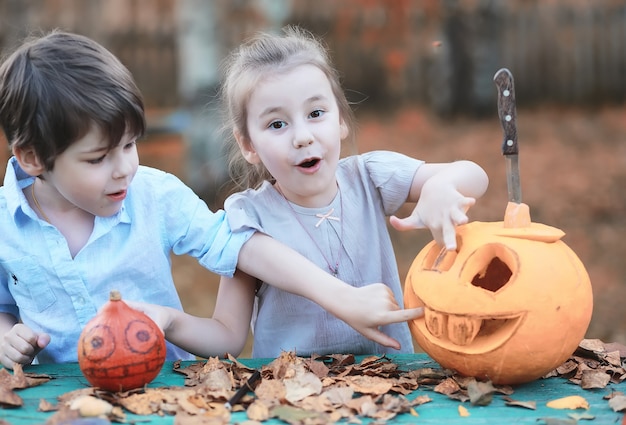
[78,291,166,391]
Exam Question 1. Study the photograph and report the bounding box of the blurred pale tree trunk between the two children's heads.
[177,0,291,208]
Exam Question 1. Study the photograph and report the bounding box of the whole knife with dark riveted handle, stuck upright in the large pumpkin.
[493,68,522,204]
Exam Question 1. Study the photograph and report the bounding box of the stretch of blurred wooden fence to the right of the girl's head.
[291,0,626,115]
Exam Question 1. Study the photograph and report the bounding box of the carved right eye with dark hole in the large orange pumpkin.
[461,244,517,292]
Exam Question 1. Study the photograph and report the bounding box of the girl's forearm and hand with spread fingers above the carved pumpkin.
[389,161,489,250]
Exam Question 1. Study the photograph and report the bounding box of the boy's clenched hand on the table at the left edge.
[0,323,50,369]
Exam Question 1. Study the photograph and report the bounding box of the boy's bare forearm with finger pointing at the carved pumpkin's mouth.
[236,232,423,349]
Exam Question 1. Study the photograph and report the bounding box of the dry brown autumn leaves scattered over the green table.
[0,340,626,425]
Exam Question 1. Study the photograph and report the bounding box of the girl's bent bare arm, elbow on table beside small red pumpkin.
[127,270,256,358]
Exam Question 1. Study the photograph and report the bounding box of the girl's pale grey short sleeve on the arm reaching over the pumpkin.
[360,151,424,215]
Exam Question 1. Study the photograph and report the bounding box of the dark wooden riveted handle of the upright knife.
[493,68,519,155]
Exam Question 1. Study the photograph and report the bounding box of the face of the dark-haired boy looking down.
[43,121,139,217]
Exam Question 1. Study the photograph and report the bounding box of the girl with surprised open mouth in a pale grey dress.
[133,28,488,357]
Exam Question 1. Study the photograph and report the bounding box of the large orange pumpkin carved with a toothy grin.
[404,204,593,384]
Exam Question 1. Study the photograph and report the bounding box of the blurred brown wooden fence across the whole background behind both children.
[0,0,626,115]
